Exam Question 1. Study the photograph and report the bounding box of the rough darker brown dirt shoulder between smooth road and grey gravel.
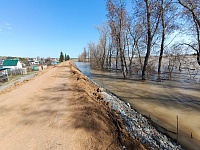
[70,62,147,150]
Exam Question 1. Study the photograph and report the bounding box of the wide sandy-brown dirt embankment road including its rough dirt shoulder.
[0,62,145,150]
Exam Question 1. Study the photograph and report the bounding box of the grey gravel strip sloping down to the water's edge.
[76,62,183,150]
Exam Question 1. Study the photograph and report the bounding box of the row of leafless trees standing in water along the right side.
[79,0,200,79]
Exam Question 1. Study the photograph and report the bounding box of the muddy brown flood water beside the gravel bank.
[76,62,200,150]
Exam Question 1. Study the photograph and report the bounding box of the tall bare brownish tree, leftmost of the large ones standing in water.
[107,0,128,78]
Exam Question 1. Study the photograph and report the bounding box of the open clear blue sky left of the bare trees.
[0,0,107,57]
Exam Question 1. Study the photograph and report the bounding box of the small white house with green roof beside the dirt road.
[2,60,22,70]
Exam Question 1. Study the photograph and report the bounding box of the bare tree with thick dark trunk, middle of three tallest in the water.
[133,0,161,80]
